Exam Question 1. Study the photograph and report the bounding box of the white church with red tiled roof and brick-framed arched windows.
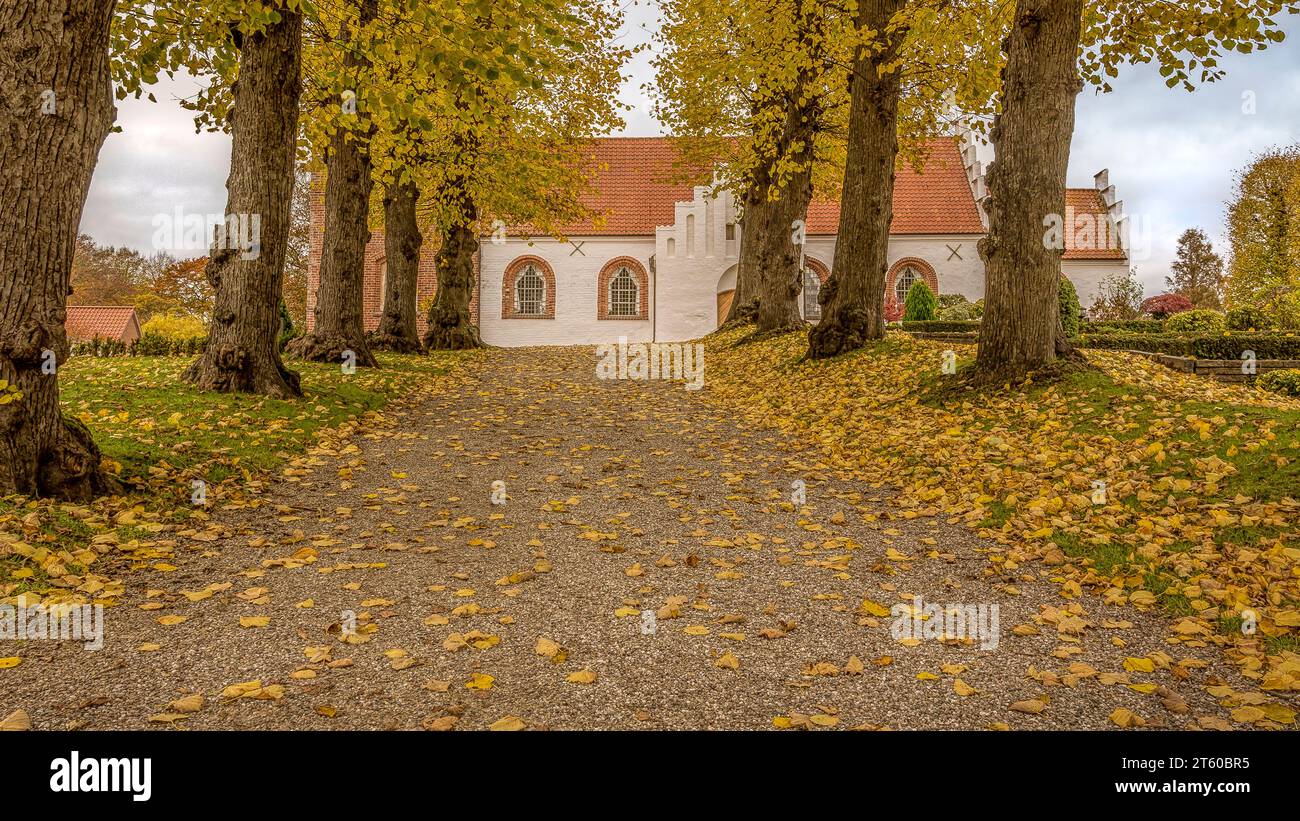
[308,138,1128,347]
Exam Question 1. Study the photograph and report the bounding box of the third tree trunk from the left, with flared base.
[290,0,378,368]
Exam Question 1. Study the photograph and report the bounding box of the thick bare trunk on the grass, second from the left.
[185,8,303,398]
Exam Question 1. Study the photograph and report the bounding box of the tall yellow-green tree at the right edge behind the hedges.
[1227,144,1300,327]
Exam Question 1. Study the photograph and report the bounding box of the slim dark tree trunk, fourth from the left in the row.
[369,179,424,353]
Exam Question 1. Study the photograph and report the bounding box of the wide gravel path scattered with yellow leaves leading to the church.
[0,348,1258,729]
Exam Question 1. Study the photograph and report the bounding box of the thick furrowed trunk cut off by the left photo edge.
[0,0,117,500]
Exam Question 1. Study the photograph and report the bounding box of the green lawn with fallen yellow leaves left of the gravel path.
[0,352,473,599]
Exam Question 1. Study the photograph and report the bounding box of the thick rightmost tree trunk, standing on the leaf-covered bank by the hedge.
[976,0,1083,375]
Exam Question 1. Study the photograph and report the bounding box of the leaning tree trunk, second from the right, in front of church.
[809,0,905,359]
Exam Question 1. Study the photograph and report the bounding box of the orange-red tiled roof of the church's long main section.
[548,136,984,236]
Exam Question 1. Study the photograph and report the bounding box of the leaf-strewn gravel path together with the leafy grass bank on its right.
[0,335,1300,729]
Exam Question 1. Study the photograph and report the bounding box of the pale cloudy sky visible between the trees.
[82,0,1300,295]
